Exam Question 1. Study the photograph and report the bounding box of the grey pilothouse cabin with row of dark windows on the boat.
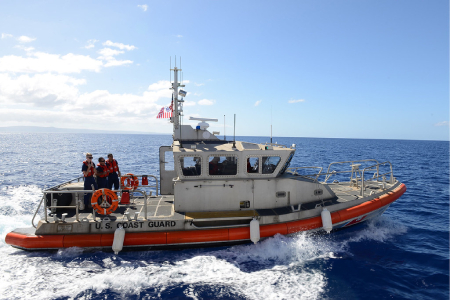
[156,121,335,212]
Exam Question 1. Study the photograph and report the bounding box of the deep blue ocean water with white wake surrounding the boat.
[0,133,449,299]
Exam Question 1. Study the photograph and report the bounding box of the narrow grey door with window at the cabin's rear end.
[159,146,177,195]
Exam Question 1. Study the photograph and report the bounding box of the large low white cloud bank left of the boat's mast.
[0,74,171,129]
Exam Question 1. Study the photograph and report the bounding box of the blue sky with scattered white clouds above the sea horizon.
[0,0,449,140]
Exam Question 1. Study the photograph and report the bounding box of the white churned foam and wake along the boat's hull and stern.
[0,187,406,299]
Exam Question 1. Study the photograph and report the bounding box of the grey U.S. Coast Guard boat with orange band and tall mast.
[6,67,406,253]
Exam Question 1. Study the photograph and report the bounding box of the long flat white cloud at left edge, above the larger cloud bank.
[0,52,103,73]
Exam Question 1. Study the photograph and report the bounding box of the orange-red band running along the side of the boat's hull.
[5,184,406,250]
